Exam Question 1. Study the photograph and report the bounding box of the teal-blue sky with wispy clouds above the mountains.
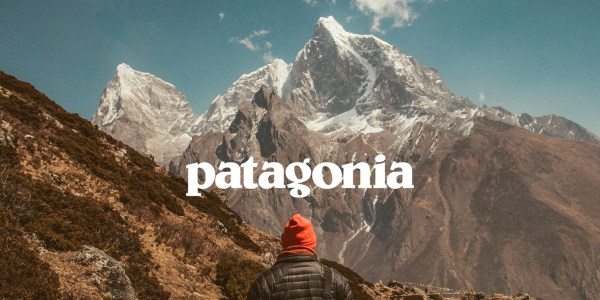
[0,0,600,134]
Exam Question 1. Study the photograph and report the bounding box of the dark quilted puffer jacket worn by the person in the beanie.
[246,254,353,300]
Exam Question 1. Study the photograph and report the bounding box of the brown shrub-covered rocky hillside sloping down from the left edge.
[0,73,277,299]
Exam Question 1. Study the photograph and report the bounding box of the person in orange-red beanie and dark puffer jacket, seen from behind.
[246,214,353,300]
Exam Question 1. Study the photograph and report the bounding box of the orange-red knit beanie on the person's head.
[281,214,317,250]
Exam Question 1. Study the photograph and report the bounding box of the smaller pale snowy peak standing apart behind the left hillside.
[92,64,201,165]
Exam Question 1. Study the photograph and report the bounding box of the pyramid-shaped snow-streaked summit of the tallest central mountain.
[283,17,455,119]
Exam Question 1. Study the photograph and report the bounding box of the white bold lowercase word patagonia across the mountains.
[186,154,414,198]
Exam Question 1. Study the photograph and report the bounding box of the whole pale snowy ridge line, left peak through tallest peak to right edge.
[92,17,600,165]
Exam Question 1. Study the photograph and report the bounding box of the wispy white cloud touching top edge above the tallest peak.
[353,0,422,33]
